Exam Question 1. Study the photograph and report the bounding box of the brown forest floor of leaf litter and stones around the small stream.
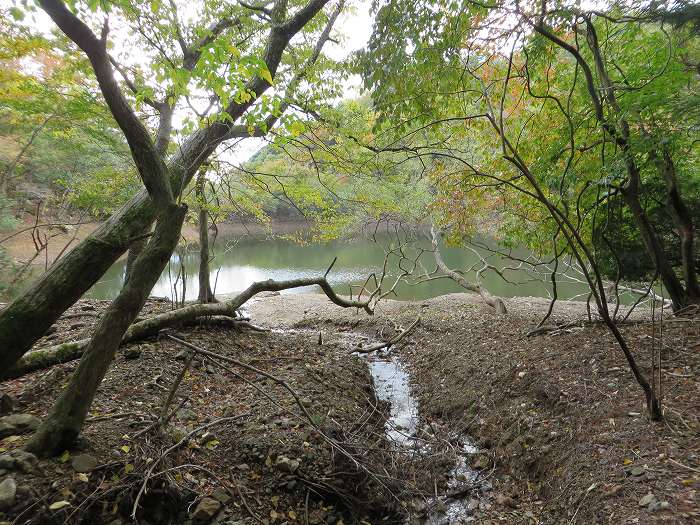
[0,294,700,525]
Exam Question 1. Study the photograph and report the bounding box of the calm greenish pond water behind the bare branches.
[86,237,587,300]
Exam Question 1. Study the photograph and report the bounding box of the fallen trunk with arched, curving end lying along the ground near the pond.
[0,276,373,380]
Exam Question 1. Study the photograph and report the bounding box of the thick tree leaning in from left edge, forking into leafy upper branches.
[0,0,344,368]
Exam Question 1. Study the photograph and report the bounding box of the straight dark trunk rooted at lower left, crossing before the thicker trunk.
[27,204,187,456]
